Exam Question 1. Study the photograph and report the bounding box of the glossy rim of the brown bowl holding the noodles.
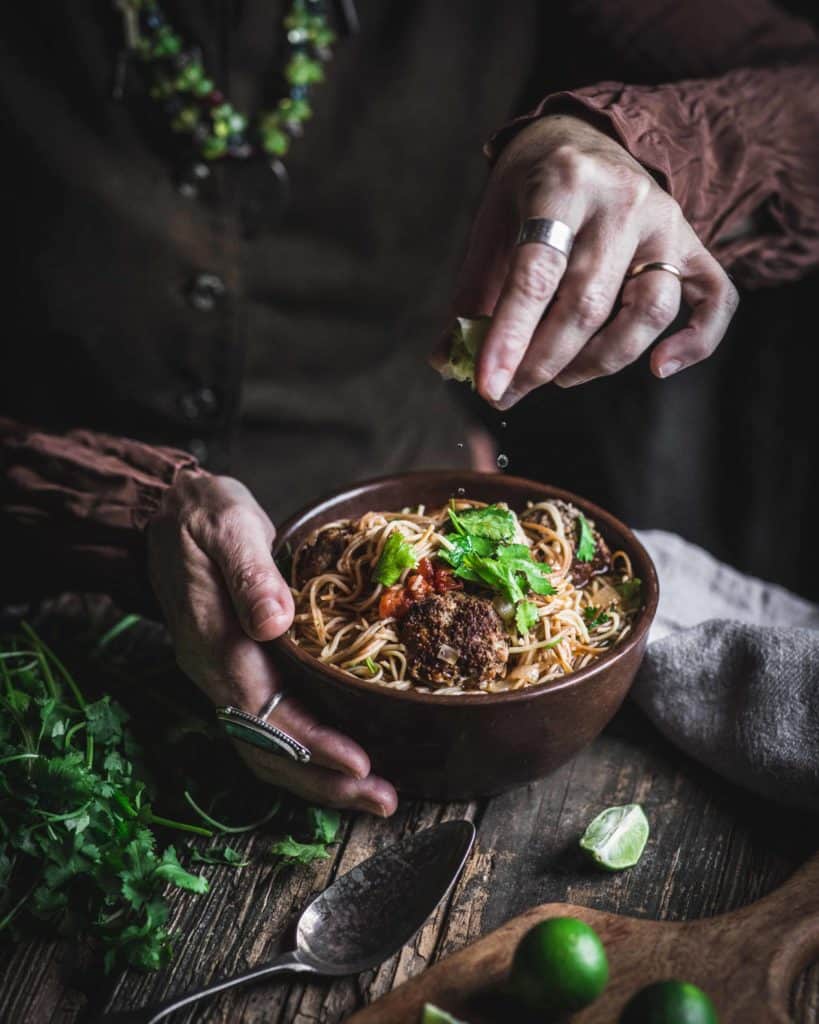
[271,469,659,708]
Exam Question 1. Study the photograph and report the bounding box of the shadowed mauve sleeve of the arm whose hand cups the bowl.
[0,419,197,611]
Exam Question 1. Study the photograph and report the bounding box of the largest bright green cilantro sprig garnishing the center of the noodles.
[438,505,555,634]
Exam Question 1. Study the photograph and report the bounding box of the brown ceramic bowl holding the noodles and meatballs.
[273,471,658,800]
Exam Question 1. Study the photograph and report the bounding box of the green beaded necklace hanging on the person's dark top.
[114,0,336,184]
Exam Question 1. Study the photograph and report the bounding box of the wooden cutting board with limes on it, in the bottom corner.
[348,854,819,1024]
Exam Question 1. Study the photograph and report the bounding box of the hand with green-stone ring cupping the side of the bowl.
[147,471,397,815]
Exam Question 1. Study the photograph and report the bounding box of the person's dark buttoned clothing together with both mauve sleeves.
[0,0,819,599]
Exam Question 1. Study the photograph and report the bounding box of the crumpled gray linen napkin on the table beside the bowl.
[632,530,819,810]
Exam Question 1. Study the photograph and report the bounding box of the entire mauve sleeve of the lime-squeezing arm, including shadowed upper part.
[487,0,819,287]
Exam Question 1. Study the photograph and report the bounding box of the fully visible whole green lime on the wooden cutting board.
[509,918,608,1014]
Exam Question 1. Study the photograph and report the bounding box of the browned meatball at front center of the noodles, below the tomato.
[398,592,509,689]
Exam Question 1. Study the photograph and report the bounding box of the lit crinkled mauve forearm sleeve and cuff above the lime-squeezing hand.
[486,60,819,287]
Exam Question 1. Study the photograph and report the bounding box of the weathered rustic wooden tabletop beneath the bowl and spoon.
[0,598,819,1024]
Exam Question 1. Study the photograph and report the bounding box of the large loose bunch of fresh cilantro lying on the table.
[0,626,212,969]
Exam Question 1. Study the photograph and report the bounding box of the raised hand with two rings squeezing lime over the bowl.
[432,116,738,410]
